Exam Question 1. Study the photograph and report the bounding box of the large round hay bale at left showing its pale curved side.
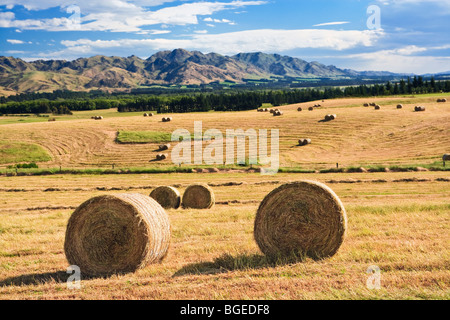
[64,193,171,275]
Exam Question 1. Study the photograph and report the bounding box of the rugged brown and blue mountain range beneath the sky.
[0,49,402,93]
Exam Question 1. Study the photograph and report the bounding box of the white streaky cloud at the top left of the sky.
[0,0,266,32]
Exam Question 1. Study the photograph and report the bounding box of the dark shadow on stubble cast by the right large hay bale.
[172,253,309,277]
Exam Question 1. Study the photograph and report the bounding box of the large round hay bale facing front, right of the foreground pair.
[254,180,347,259]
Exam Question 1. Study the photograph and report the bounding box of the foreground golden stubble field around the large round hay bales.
[0,172,450,300]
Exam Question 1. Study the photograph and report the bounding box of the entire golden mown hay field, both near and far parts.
[0,96,450,300]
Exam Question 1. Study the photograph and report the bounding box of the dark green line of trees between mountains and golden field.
[0,76,450,114]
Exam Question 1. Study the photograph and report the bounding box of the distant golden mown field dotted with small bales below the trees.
[0,95,450,169]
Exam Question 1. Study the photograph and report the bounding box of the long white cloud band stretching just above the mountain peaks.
[52,29,383,57]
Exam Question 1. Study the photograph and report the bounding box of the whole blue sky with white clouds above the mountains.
[0,0,450,74]
